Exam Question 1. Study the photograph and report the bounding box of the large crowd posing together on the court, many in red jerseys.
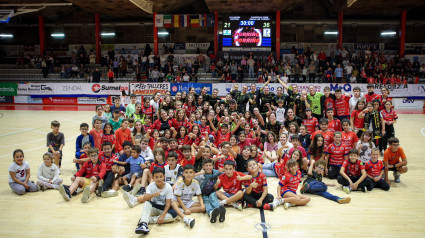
[9,77,407,234]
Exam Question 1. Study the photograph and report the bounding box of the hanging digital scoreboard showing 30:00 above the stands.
[222,16,272,48]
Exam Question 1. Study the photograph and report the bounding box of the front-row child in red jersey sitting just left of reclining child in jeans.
[277,159,310,210]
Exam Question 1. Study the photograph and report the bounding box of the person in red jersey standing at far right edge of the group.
[379,101,398,151]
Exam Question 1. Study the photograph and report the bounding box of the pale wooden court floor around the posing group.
[0,110,425,238]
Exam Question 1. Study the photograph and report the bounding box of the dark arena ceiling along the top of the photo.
[0,0,425,22]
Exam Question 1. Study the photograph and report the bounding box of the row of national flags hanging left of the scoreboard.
[155,14,215,27]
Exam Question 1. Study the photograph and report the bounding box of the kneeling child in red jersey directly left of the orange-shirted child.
[365,148,390,191]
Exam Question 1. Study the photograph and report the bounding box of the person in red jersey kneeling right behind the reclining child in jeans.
[325,131,348,179]
